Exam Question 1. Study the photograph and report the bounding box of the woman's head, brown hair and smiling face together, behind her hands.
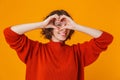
[42,10,74,42]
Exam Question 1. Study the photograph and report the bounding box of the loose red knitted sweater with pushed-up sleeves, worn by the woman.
[4,28,113,80]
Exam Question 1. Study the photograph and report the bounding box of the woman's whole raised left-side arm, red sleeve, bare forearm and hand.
[4,15,59,63]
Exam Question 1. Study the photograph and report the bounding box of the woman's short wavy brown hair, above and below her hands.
[42,10,74,40]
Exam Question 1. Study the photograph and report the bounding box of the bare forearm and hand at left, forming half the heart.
[11,15,58,34]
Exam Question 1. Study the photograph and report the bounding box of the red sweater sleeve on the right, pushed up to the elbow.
[76,32,113,66]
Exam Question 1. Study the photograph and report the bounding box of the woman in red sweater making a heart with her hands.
[4,10,113,80]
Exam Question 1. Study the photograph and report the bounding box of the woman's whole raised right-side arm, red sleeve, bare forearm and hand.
[61,15,113,66]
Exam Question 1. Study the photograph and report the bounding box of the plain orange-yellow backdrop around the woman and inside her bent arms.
[0,0,120,80]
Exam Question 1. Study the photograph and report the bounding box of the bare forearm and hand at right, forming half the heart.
[61,15,103,38]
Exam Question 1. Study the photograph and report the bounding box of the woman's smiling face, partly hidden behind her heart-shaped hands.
[52,21,70,42]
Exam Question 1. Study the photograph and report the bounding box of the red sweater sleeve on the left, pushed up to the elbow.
[4,27,38,63]
